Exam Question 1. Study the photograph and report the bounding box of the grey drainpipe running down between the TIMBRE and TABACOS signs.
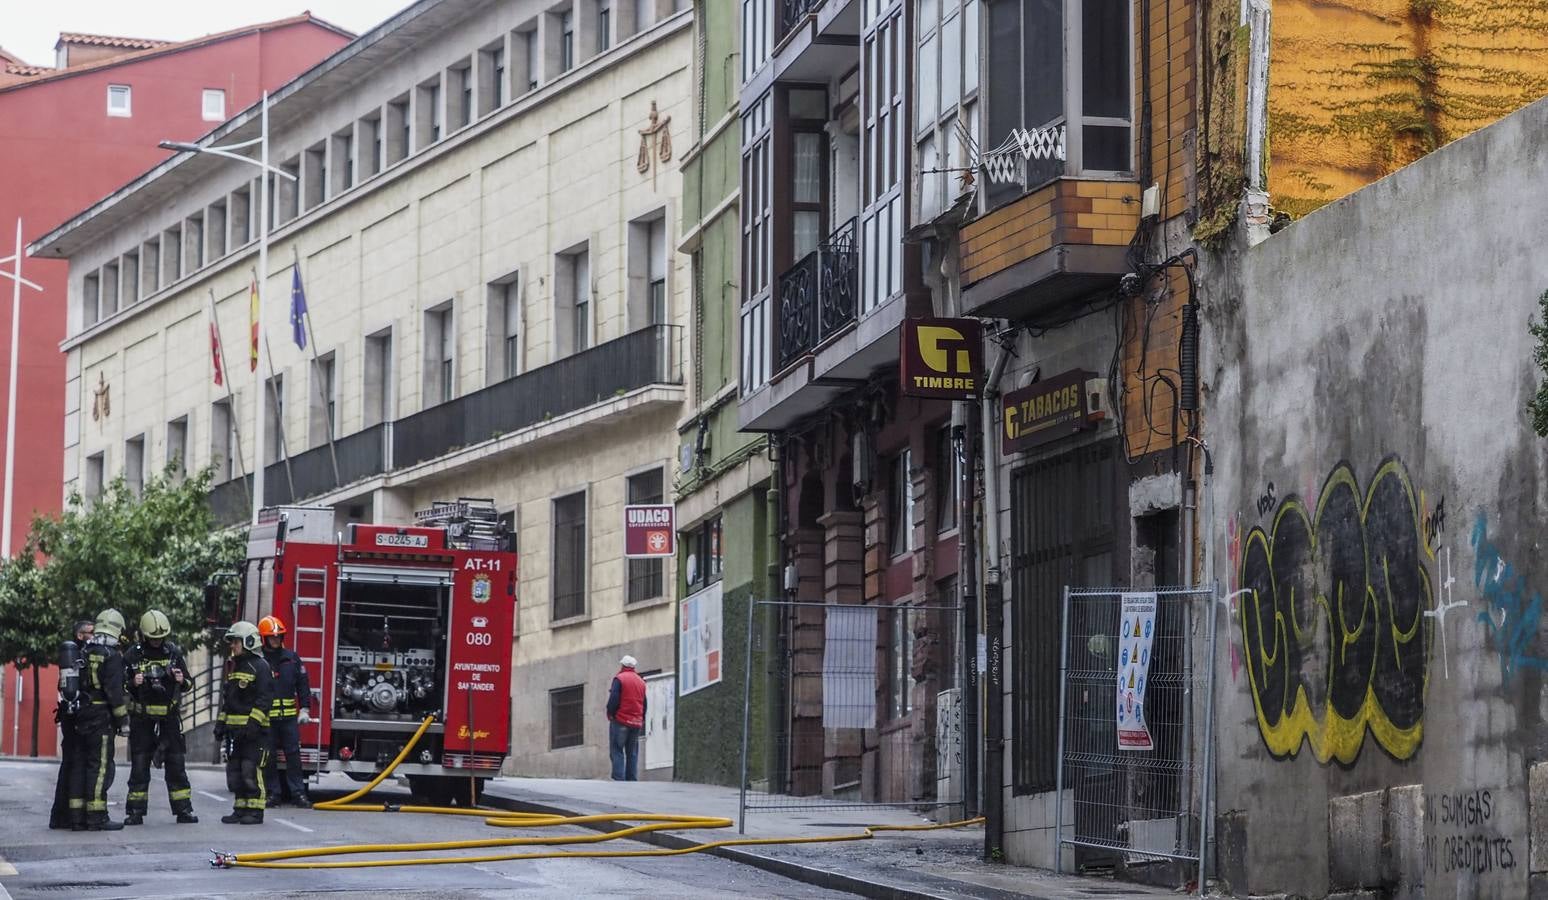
[978,331,1014,860]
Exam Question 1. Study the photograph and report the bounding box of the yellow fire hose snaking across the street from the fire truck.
[209,716,983,869]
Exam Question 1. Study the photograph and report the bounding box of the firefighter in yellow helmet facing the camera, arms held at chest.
[124,609,198,826]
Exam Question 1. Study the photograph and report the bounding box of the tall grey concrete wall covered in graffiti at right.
[1204,94,1548,898]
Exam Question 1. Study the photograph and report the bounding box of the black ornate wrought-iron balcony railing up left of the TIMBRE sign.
[776,218,859,370]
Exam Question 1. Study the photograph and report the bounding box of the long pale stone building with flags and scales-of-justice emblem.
[31,0,694,778]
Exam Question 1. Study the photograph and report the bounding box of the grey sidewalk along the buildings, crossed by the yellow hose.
[485,778,1176,900]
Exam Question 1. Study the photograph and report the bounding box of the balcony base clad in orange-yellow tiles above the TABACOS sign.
[961,178,1139,319]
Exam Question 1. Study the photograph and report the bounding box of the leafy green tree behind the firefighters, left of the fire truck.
[0,466,246,756]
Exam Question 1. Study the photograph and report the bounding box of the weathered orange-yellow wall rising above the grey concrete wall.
[1269,0,1548,217]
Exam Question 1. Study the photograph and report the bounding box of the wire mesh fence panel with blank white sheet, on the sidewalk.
[740,599,968,829]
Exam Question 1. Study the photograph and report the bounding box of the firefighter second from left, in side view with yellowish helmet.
[70,609,128,832]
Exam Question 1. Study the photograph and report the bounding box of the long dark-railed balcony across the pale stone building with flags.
[209,325,683,525]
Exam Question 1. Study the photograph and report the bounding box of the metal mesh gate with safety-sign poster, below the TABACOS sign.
[1054,587,1215,895]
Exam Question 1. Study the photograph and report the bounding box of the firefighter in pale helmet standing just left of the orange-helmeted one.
[215,621,274,826]
